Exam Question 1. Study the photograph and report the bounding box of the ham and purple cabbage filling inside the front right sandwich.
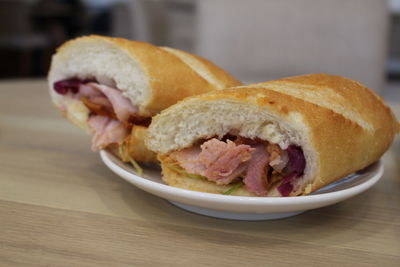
[169,136,306,196]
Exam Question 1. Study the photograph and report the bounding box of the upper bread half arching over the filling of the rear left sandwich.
[49,35,241,116]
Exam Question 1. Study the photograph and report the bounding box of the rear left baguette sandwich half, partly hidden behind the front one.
[48,35,240,162]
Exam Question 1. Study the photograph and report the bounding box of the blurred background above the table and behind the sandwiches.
[0,0,400,98]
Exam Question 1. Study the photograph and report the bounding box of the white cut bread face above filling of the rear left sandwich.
[48,37,150,114]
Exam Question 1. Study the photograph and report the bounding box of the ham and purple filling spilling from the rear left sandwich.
[53,78,151,151]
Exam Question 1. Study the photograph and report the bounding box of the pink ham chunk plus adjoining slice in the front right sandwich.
[170,138,269,196]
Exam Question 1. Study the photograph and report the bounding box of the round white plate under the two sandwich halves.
[100,150,383,220]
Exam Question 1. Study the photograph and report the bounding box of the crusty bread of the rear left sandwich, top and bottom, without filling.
[48,35,241,161]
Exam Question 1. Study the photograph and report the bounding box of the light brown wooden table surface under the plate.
[0,80,400,266]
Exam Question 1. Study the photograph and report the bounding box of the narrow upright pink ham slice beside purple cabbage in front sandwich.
[243,144,269,196]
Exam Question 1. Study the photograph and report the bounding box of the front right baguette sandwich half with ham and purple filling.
[145,74,400,197]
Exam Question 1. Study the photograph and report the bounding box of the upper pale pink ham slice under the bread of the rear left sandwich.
[87,83,138,122]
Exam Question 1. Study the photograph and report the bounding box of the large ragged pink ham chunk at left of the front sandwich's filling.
[170,138,253,184]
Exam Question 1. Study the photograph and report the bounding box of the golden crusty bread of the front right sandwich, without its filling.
[146,74,399,195]
